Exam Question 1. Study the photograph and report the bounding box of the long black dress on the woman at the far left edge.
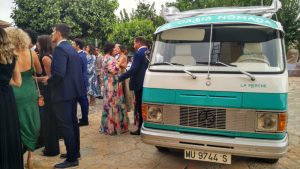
[0,58,23,169]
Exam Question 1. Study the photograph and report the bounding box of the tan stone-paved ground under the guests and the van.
[30,78,300,169]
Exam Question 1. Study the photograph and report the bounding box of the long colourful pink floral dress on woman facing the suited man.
[100,55,129,135]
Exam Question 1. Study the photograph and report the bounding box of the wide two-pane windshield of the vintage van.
[150,25,284,73]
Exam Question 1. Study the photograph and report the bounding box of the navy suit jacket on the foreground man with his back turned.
[48,41,86,102]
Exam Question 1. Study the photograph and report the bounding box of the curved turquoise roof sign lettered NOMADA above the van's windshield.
[154,14,283,34]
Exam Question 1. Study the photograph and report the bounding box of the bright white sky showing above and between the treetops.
[0,0,175,22]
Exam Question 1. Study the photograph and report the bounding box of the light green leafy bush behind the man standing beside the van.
[108,19,155,49]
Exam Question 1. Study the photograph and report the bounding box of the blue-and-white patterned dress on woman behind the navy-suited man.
[86,55,100,97]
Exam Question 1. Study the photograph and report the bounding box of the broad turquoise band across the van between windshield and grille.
[143,88,287,111]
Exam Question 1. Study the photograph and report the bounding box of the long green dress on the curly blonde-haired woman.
[13,51,40,151]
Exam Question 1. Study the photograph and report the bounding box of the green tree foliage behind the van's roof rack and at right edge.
[167,0,300,49]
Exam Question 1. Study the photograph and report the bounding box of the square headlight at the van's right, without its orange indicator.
[256,112,278,132]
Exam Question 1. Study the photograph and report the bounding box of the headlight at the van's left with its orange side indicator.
[142,104,163,123]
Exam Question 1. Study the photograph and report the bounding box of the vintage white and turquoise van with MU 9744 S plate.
[141,0,288,164]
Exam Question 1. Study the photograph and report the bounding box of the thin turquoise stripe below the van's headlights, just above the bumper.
[144,122,287,140]
